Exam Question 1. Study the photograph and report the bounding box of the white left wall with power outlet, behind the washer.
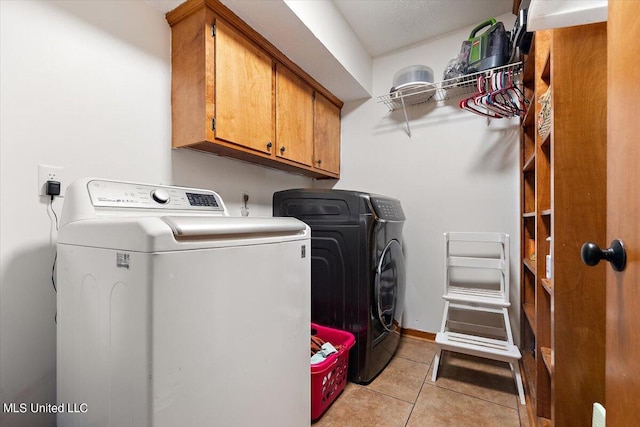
[0,0,312,427]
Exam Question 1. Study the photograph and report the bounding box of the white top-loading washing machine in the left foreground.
[57,179,311,427]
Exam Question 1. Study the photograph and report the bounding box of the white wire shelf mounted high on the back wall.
[378,62,522,115]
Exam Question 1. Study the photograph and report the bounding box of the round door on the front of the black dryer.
[373,240,405,332]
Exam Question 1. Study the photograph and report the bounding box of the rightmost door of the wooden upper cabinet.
[313,92,340,174]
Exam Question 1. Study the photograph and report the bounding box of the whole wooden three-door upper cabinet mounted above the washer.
[167,0,342,178]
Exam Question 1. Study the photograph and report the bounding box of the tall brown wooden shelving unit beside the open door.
[520,23,607,426]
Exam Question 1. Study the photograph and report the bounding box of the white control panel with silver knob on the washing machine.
[87,180,225,215]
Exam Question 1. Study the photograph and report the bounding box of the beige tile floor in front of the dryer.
[313,337,529,427]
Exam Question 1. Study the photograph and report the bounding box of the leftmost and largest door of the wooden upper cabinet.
[214,20,274,153]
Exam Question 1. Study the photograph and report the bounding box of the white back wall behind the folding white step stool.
[324,11,520,340]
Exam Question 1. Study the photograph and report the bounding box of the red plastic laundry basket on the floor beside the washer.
[311,323,355,421]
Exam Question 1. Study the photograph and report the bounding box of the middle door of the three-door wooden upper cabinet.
[276,64,313,166]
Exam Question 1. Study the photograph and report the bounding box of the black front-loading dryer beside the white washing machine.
[273,189,406,384]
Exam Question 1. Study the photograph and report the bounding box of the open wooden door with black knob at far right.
[602,0,640,427]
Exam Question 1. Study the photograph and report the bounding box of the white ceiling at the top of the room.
[146,0,513,57]
